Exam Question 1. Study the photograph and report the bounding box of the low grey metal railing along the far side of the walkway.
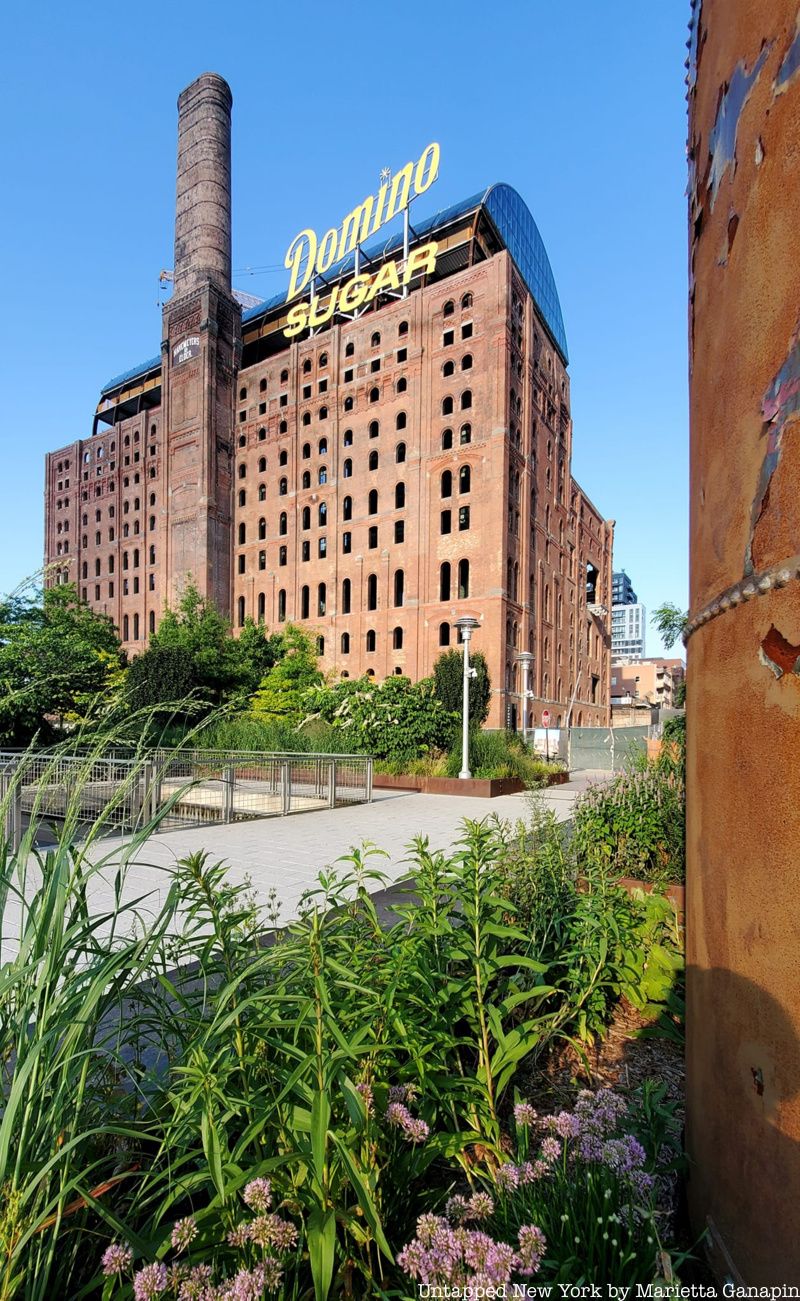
[0,749,372,846]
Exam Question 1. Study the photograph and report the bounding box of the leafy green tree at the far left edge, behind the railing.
[0,583,125,745]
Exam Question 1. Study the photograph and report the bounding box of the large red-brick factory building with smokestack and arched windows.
[46,74,613,727]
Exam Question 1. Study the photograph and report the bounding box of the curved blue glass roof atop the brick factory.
[100,183,570,394]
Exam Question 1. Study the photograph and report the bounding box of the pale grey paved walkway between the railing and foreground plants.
[0,774,602,956]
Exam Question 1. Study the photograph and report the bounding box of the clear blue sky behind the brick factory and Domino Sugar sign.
[0,0,688,653]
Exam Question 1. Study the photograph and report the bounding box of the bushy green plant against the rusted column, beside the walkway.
[574,756,686,883]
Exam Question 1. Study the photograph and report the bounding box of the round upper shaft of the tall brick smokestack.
[174,73,233,298]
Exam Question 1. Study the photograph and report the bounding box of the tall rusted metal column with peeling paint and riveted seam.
[687,0,800,1285]
